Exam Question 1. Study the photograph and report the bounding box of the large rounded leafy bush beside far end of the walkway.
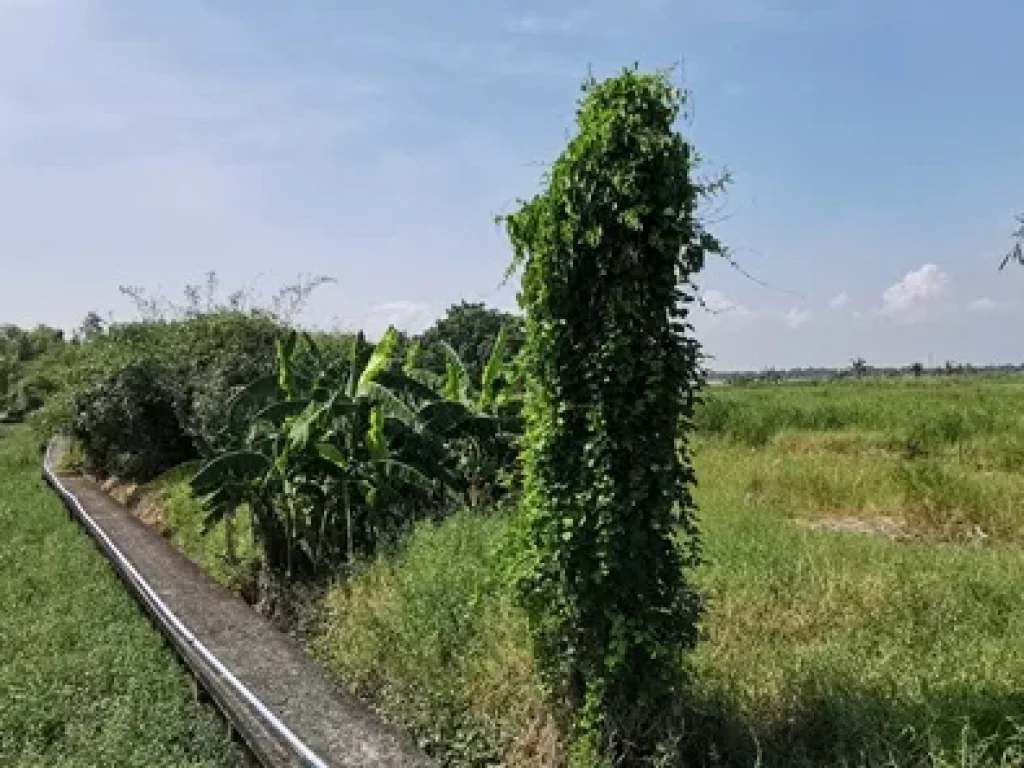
[33,314,284,481]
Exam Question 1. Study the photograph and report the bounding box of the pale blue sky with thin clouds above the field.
[0,0,1024,370]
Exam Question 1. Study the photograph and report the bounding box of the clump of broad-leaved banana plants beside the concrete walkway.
[193,329,520,593]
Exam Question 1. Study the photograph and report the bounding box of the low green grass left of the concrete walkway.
[0,427,242,768]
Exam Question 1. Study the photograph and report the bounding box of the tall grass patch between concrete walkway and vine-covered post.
[312,512,541,766]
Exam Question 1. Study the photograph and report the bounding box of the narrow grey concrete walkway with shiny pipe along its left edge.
[43,438,433,768]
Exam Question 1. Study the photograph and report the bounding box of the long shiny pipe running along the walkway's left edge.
[43,441,329,768]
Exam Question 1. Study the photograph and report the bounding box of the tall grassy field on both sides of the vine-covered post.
[312,377,1024,768]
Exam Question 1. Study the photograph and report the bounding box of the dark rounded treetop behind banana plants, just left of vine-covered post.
[417,301,525,381]
